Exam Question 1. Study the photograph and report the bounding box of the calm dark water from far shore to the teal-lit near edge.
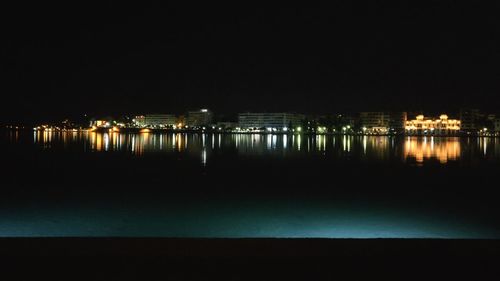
[0,131,500,238]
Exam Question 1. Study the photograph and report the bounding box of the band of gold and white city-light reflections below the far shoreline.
[25,131,500,165]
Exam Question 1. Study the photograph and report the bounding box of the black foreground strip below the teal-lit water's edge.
[0,238,500,280]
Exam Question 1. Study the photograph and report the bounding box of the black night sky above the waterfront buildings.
[0,1,500,120]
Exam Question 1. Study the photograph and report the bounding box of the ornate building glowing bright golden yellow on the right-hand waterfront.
[405,114,460,135]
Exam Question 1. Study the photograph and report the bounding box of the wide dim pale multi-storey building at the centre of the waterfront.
[238,113,304,131]
